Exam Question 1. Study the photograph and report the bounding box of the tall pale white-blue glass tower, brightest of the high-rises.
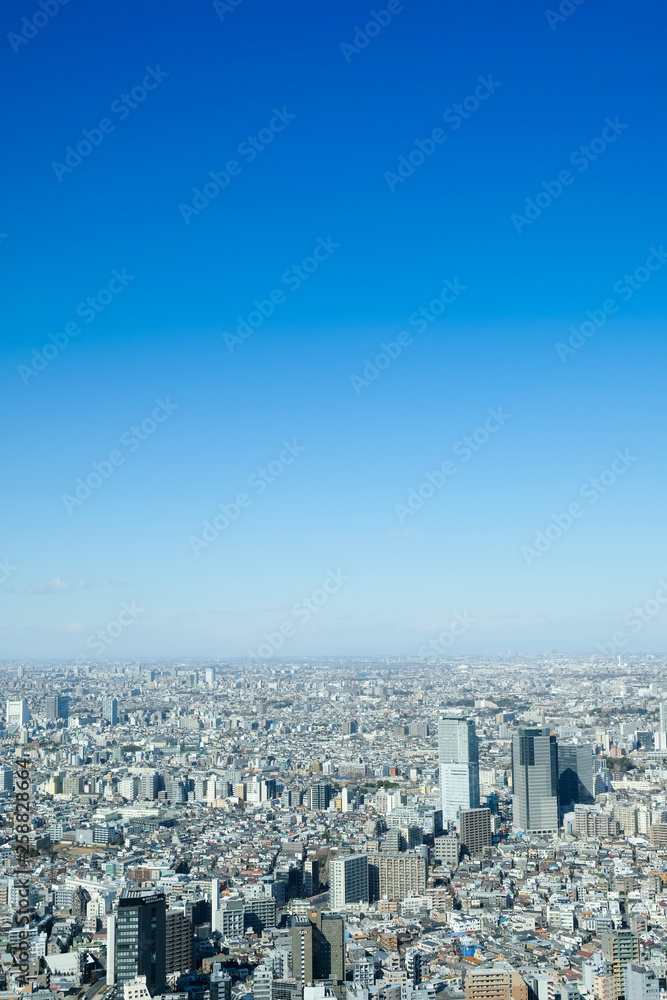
[438,717,479,823]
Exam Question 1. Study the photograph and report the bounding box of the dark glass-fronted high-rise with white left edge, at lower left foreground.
[116,889,167,996]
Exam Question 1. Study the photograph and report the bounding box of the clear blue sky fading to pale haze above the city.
[0,0,667,659]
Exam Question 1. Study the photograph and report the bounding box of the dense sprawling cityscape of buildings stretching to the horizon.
[0,654,667,1000]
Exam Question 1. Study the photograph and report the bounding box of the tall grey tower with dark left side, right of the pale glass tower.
[512,729,558,835]
